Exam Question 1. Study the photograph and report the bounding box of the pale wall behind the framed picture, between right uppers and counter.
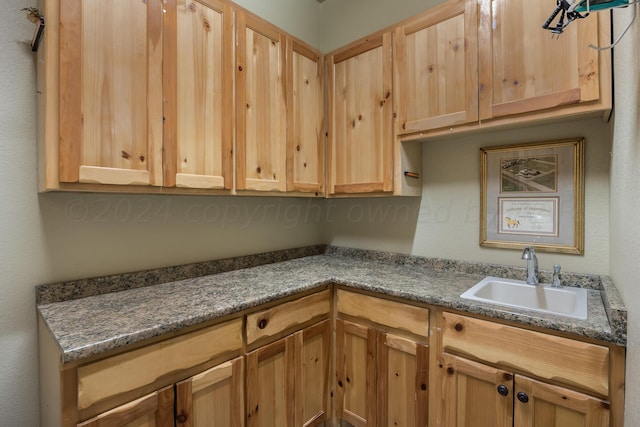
[328,119,611,274]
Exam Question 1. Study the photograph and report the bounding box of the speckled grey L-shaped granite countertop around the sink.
[36,247,626,363]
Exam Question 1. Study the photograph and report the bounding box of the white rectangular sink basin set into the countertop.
[460,277,588,320]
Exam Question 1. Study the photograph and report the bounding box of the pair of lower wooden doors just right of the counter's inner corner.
[336,319,429,427]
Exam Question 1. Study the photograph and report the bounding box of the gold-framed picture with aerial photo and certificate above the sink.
[480,138,584,254]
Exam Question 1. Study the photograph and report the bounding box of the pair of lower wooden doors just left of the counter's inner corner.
[246,320,330,427]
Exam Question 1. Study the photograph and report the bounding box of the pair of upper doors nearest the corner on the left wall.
[236,10,324,194]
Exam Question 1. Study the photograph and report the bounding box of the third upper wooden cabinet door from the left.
[236,11,287,191]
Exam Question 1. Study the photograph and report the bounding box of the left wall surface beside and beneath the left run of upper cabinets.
[0,0,324,427]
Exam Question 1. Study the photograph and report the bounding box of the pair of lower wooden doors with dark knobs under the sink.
[442,354,609,427]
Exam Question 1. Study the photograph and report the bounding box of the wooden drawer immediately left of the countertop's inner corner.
[247,290,331,345]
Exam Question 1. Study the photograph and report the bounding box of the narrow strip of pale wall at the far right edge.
[611,8,640,427]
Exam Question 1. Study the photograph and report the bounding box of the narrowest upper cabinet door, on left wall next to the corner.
[287,37,324,193]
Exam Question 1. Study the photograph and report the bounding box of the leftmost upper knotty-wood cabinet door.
[59,0,163,186]
